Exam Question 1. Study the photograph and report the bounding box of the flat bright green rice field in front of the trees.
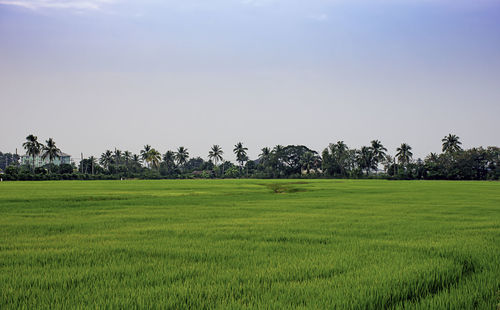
[0,180,500,309]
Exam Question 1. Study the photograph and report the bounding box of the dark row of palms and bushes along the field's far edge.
[0,134,500,180]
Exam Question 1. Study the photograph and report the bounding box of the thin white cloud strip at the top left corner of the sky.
[0,0,114,10]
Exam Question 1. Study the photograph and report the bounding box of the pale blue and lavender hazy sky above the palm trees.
[0,0,500,161]
